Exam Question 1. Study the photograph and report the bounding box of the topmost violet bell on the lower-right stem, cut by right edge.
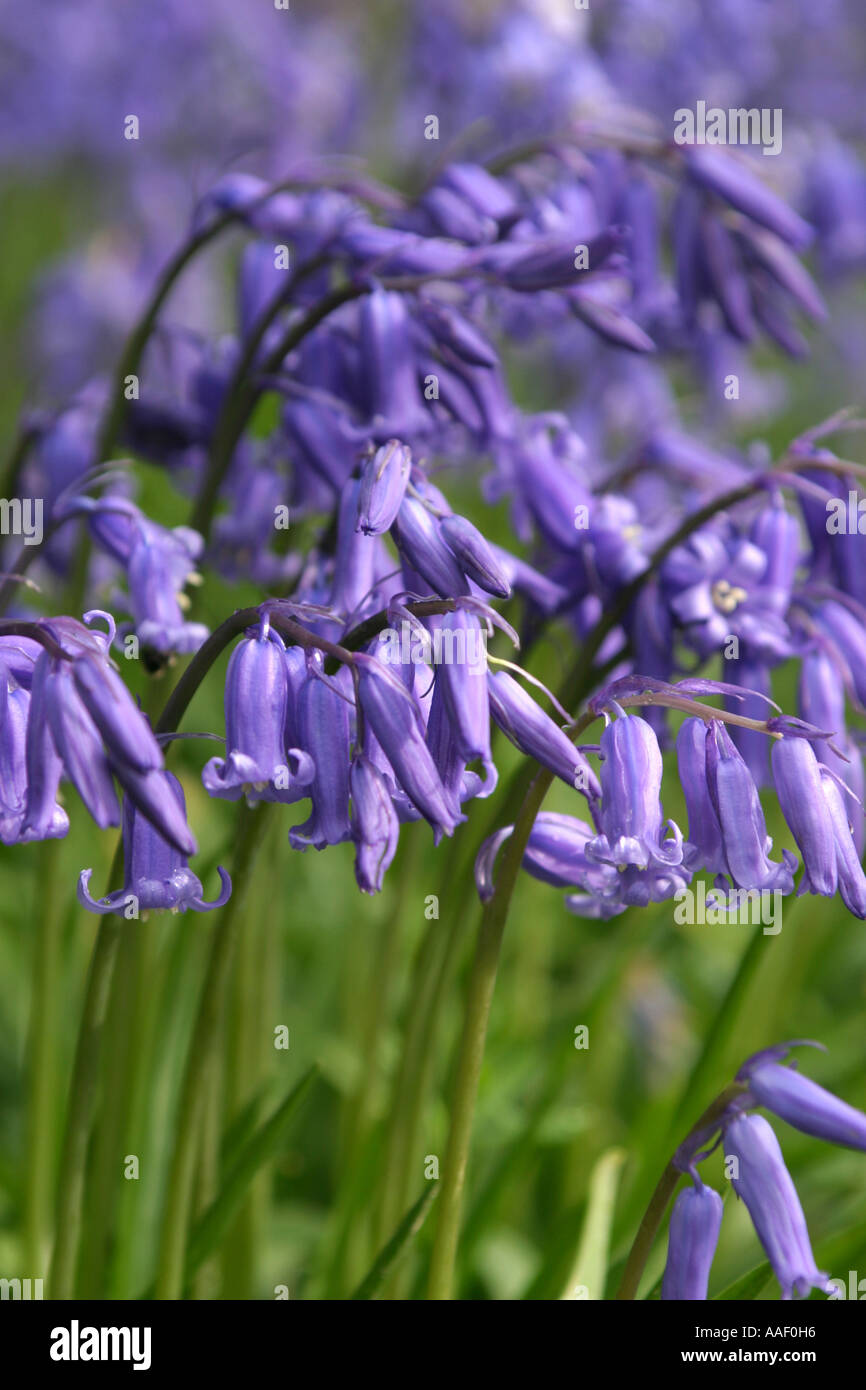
[737,1043,866,1151]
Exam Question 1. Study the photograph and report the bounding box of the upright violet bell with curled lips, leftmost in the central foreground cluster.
[202,623,316,803]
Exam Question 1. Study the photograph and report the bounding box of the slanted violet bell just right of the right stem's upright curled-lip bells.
[706,720,796,894]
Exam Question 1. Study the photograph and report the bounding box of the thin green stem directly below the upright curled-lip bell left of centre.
[156,806,264,1300]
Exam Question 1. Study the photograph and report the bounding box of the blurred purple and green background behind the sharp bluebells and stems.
[0,0,866,1298]
